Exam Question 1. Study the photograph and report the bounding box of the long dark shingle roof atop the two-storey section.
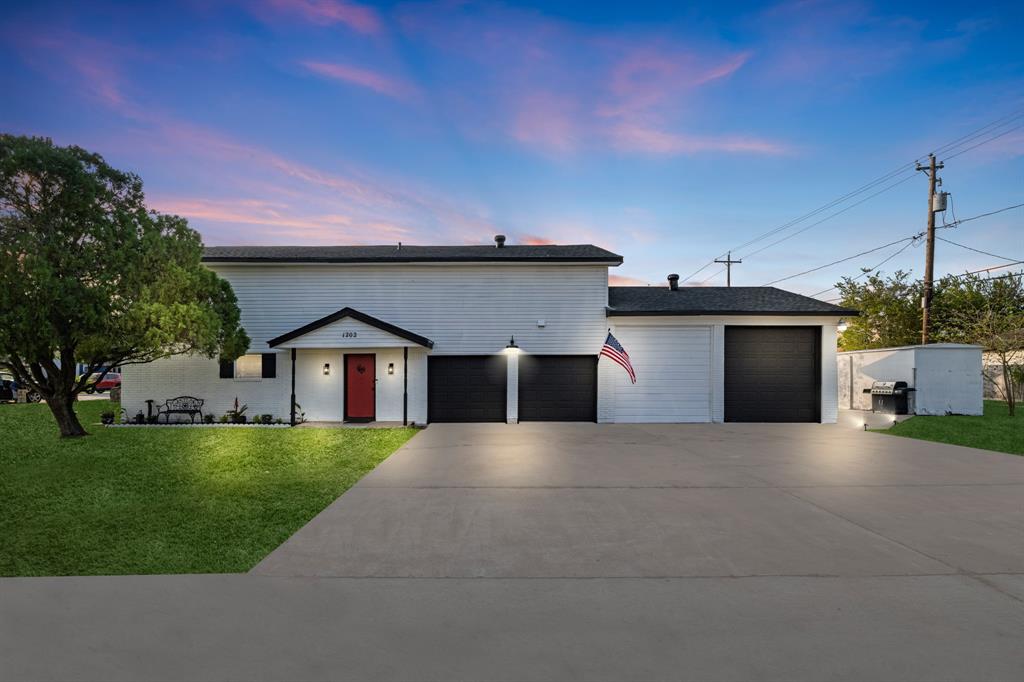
[203,244,623,265]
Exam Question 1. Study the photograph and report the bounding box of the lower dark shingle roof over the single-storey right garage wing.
[608,287,857,315]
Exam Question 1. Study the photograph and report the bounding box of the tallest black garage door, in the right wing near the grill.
[725,327,821,422]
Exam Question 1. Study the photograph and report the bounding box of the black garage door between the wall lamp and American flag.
[519,355,597,422]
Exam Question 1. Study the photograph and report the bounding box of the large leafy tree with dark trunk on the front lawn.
[0,135,249,436]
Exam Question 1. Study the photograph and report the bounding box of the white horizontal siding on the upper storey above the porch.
[207,263,608,354]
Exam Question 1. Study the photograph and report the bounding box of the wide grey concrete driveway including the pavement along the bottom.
[6,424,1024,680]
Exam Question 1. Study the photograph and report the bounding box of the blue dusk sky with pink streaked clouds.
[0,0,1024,297]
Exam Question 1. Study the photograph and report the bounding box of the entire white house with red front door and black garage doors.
[122,238,851,424]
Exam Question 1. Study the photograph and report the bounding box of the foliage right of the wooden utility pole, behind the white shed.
[936,275,1024,417]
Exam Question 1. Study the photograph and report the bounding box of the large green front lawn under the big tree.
[0,400,416,576]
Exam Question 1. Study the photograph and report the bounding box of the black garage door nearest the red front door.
[427,355,508,422]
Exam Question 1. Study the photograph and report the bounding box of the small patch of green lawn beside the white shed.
[882,400,1024,455]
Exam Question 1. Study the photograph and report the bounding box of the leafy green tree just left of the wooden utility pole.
[836,270,923,350]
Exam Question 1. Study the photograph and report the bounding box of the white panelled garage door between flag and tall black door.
[600,325,712,424]
